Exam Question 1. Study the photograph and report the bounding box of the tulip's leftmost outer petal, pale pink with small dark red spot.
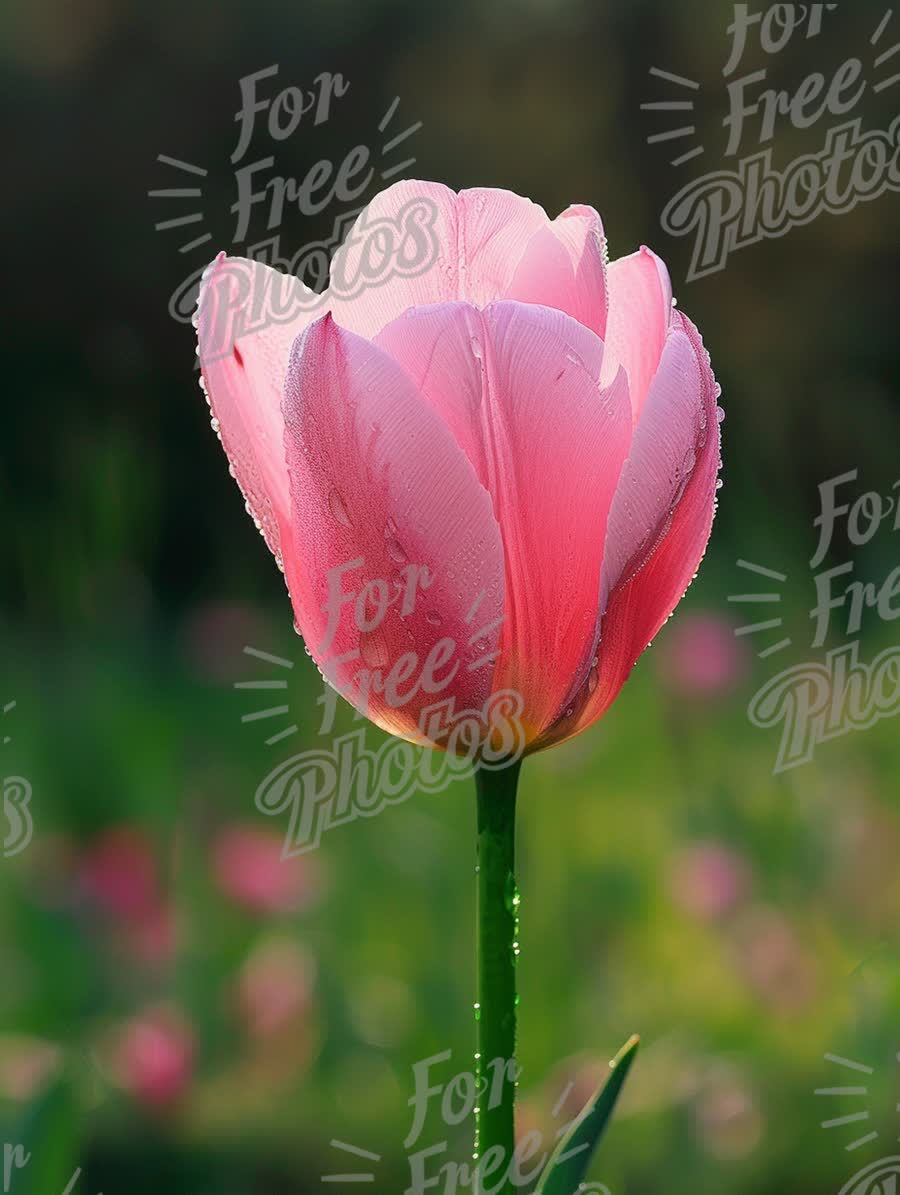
[197,255,323,559]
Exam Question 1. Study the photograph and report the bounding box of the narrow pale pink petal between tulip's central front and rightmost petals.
[602,246,672,422]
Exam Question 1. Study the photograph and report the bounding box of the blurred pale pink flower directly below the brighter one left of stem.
[235,940,316,1037]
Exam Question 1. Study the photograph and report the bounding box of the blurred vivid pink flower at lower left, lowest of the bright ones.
[114,1006,194,1108]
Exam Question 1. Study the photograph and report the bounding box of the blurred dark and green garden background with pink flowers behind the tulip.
[0,0,900,1195]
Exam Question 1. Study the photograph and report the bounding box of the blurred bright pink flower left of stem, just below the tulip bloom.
[213,826,319,913]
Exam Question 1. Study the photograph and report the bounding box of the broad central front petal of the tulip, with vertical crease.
[378,301,631,736]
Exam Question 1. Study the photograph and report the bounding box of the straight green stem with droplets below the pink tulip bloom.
[475,760,521,1195]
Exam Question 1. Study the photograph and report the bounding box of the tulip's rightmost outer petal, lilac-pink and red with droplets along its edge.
[546,312,720,744]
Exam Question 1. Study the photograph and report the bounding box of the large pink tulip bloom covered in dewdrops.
[197,182,721,752]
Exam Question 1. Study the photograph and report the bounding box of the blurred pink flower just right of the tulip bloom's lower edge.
[656,614,747,698]
